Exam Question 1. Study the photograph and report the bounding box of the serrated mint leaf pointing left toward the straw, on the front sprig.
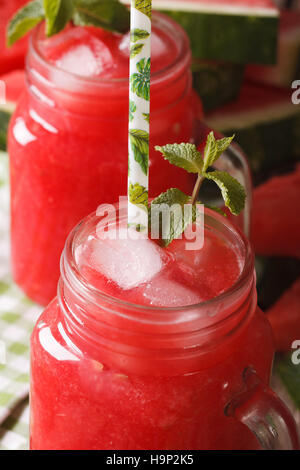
[155,144,203,173]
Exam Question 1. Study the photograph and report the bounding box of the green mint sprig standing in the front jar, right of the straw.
[149,132,246,246]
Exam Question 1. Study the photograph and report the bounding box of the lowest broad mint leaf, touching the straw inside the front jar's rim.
[149,188,197,246]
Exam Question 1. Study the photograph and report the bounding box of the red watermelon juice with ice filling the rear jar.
[9,14,201,304]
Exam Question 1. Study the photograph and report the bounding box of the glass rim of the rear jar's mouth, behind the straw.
[27,12,191,87]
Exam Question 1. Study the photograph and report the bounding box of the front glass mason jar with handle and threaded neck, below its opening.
[30,210,298,450]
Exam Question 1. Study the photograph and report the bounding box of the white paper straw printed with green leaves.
[128,0,152,231]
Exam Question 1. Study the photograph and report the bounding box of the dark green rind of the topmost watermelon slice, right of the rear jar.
[163,10,279,65]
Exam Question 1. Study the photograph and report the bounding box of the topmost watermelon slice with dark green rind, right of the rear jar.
[149,0,279,64]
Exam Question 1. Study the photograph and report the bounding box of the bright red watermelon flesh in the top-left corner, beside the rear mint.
[0,0,27,75]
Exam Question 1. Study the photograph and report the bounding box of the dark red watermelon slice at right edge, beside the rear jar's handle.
[251,164,300,260]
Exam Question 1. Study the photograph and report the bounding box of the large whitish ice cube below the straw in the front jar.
[90,228,164,290]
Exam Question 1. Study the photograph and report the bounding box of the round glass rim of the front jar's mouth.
[61,208,254,316]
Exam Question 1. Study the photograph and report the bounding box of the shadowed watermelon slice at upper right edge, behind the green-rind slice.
[246,10,300,87]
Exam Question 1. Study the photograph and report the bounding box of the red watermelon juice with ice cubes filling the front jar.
[31,207,273,450]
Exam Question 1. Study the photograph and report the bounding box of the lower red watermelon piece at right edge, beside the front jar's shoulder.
[266,278,300,351]
